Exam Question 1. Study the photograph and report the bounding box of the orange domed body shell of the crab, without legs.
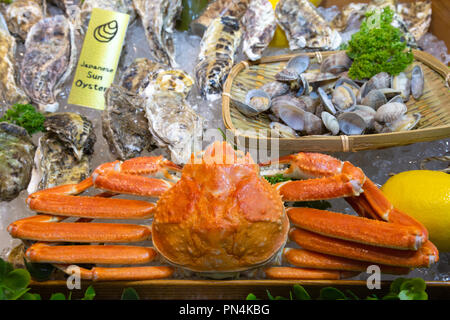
[152,143,289,272]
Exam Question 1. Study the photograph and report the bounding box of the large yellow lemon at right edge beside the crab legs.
[381,170,450,251]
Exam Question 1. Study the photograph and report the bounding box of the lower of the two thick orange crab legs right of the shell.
[289,228,439,268]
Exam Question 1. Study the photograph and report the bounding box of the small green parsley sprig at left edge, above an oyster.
[0,104,45,135]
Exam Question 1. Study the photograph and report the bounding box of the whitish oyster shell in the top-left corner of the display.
[5,0,44,40]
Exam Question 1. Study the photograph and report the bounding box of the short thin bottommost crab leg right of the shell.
[264,267,359,280]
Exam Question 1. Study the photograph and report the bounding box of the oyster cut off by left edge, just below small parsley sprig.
[0,122,36,201]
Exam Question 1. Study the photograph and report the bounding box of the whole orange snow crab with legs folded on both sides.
[8,142,438,280]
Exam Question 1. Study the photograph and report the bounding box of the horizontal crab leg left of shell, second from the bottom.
[25,242,157,264]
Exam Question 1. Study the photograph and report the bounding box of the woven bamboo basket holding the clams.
[222,50,450,152]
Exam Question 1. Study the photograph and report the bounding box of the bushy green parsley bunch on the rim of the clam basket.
[347,7,414,79]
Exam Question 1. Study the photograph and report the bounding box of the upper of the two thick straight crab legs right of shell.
[287,208,427,250]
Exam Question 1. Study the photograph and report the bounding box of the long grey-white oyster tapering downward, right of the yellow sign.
[133,0,182,67]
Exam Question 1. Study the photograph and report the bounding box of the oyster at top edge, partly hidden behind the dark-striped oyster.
[191,0,249,37]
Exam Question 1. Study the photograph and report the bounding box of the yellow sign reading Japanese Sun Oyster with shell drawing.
[68,8,130,110]
